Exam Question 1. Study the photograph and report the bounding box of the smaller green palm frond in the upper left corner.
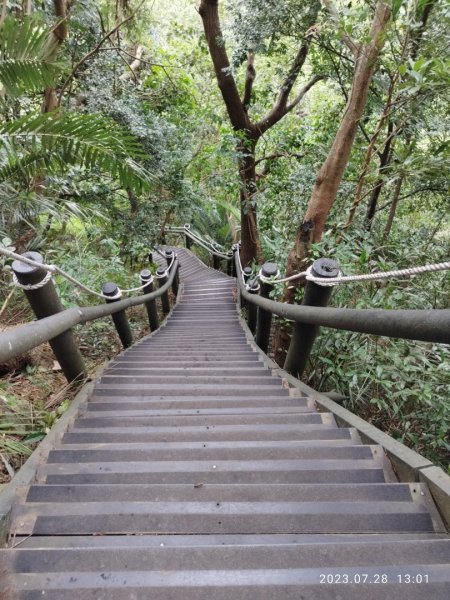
[0,16,58,96]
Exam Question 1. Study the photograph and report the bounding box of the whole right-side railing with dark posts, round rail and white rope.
[235,251,450,375]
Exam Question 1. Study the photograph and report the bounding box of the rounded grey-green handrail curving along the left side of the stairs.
[0,258,179,364]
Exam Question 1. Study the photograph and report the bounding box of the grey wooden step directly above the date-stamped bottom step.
[12,500,434,535]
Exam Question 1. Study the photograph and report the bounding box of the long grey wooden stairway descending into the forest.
[0,250,450,600]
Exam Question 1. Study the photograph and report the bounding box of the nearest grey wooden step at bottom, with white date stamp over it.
[1,538,450,600]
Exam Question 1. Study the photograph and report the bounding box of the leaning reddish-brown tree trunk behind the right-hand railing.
[285,0,392,302]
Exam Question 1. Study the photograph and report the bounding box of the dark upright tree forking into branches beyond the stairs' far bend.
[199,0,323,265]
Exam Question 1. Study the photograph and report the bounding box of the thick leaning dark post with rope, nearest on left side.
[12,252,86,382]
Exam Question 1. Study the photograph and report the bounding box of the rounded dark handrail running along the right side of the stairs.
[235,252,450,344]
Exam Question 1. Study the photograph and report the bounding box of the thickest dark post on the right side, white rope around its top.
[284,258,339,377]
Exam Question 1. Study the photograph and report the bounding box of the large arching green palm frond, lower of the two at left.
[0,111,150,190]
